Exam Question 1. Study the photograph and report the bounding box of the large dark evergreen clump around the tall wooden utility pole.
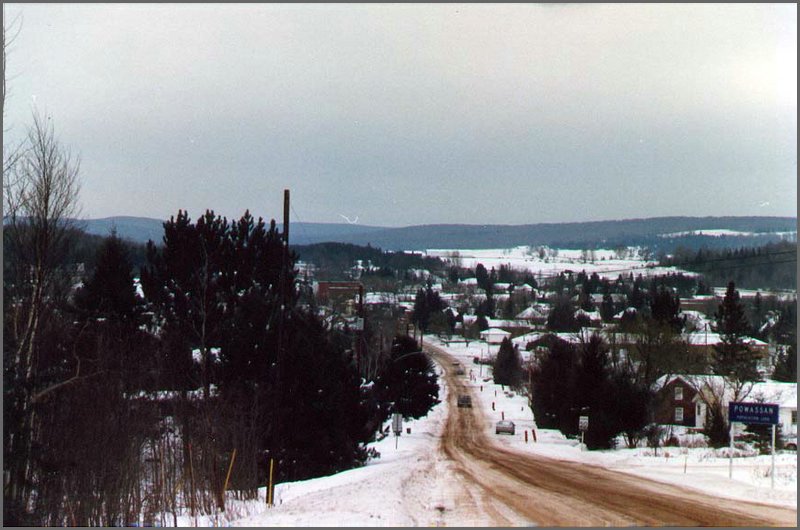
[142,211,375,487]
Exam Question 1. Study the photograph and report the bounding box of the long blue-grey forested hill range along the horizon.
[76,213,797,252]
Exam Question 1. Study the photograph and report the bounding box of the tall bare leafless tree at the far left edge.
[3,109,80,516]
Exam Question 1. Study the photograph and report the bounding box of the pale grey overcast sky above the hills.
[4,4,797,226]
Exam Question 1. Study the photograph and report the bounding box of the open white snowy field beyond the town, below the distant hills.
[424,246,694,279]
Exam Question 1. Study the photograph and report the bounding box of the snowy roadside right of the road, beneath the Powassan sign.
[425,336,797,508]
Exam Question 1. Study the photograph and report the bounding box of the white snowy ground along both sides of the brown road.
[191,336,797,526]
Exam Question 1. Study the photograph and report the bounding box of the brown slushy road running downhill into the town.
[425,345,797,527]
